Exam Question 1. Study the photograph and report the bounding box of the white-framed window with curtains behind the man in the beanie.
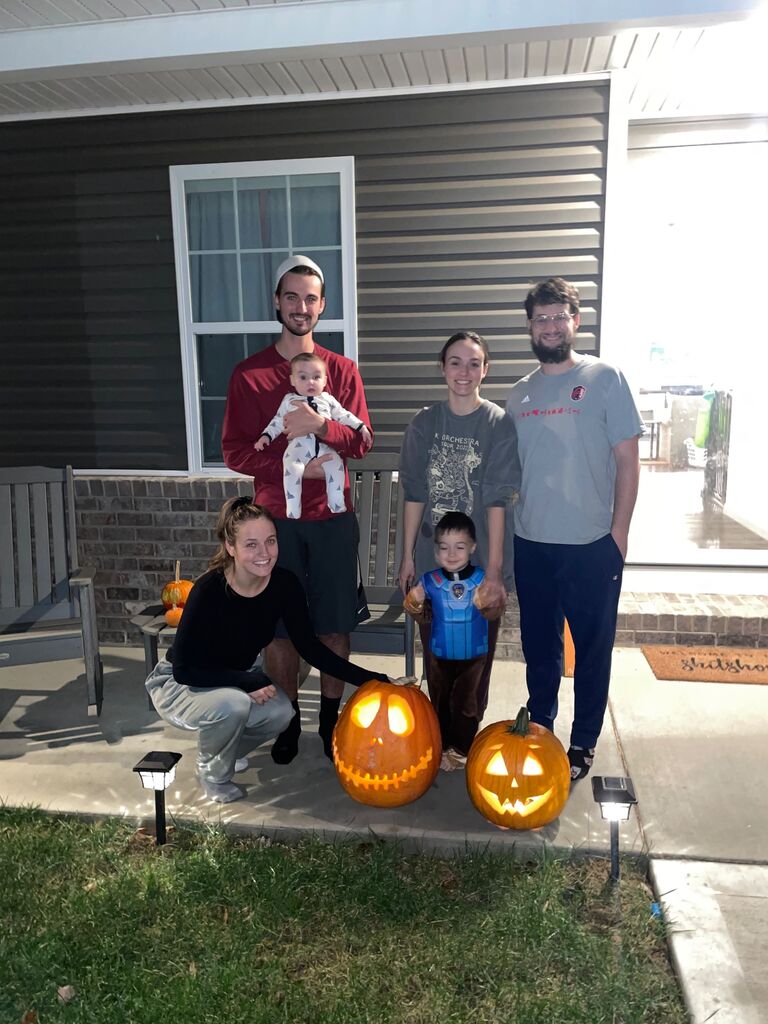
[170,157,357,472]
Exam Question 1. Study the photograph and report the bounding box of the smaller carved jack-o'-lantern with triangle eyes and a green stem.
[467,708,570,828]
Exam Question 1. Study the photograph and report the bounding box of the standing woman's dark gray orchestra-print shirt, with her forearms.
[399,399,520,589]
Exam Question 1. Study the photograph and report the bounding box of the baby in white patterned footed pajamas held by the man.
[254,352,371,519]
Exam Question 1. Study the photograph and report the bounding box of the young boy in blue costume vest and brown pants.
[404,512,504,771]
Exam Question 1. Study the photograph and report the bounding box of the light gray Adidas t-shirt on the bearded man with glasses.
[507,355,643,544]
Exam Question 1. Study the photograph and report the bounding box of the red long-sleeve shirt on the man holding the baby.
[221,343,371,520]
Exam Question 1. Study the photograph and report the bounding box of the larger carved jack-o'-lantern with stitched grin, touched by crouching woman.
[333,679,441,807]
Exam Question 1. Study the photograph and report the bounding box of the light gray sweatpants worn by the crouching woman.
[144,658,294,784]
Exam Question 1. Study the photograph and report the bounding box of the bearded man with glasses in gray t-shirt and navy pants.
[507,278,643,781]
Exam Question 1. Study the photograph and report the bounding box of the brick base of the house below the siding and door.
[75,476,768,659]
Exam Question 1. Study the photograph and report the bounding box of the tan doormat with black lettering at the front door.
[640,645,768,683]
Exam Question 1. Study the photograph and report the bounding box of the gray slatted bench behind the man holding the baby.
[131,455,415,676]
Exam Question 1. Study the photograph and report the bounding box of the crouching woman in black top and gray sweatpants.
[146,498,387,804]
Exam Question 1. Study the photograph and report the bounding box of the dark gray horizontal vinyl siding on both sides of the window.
[0,82,608,471]
